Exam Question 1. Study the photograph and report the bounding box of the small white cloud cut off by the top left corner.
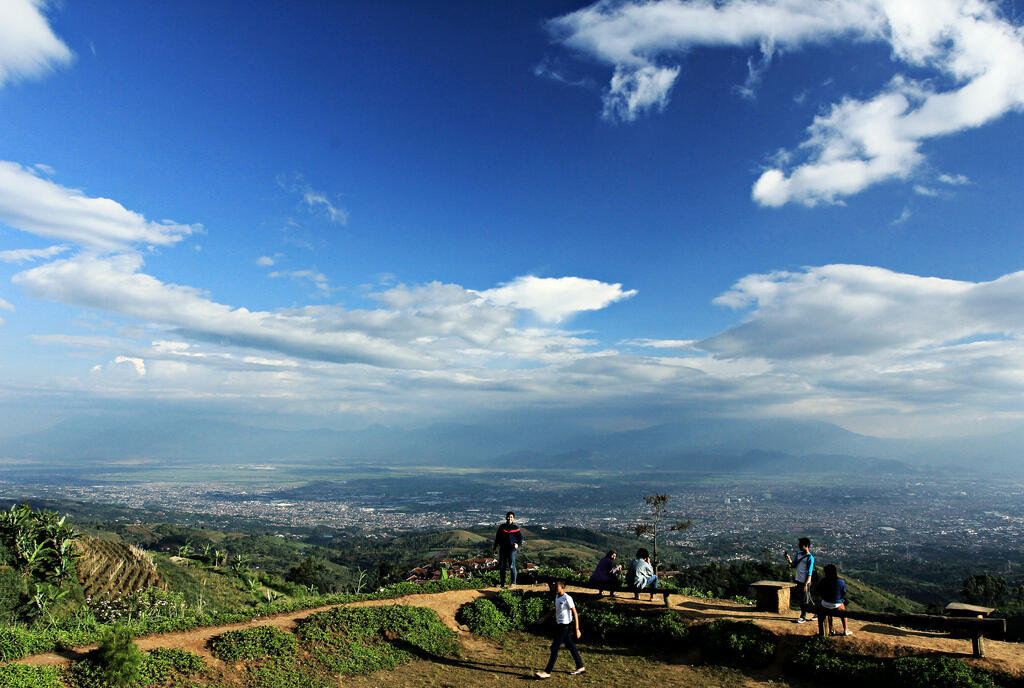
[0,0,72,87]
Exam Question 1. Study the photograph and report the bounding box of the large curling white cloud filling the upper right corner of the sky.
[549,0,1024,207]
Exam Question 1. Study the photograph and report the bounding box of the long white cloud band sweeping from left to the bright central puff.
[13,253,632,371]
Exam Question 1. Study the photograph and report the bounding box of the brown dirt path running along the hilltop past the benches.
[19,586,1024,677]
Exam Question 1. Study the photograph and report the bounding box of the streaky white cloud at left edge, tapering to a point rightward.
[0,161,198,251]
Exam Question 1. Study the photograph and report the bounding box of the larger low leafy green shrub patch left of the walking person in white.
[298,605,459,676]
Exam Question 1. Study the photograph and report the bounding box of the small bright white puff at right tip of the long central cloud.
[479,275,636,323]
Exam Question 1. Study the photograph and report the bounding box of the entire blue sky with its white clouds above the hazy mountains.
[0,0,1024,436]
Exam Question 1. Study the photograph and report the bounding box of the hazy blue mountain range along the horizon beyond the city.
[0,415,1024,475]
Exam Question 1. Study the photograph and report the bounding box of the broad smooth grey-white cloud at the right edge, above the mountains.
[698,265,1024,359]
